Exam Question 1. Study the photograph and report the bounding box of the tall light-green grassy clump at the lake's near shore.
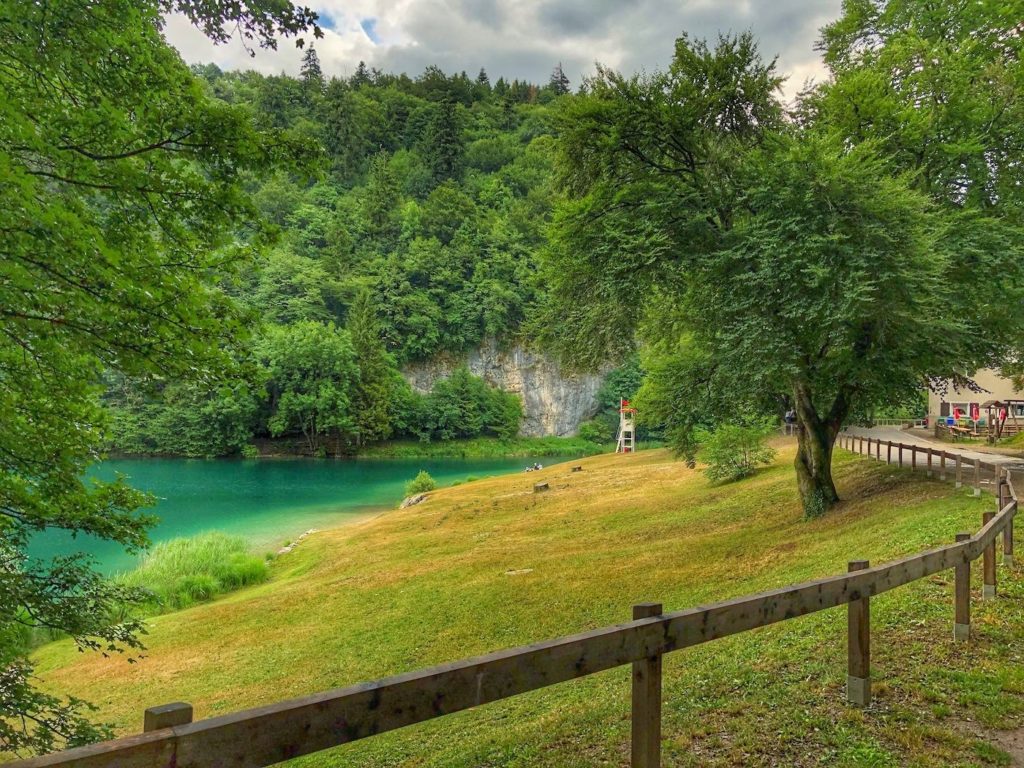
[117,532,269,610]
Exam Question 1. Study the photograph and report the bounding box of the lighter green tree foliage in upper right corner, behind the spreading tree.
[815,0,1024,387]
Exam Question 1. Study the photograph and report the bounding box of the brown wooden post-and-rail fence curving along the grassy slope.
[9,448,1024,768]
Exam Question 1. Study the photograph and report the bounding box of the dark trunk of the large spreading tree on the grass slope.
[794,385,846,518]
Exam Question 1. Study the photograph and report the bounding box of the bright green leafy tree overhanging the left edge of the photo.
[0,0,315,753]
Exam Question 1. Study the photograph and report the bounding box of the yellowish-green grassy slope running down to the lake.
[37,449,1024,768]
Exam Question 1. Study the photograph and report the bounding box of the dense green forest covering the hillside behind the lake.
[105,61,636,456]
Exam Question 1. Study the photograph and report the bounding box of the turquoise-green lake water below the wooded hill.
[30,457,571,573]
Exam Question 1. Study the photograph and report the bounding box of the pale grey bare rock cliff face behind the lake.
[402,343,602,437]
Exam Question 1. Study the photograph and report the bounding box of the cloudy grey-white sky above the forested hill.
[167,0,840,100]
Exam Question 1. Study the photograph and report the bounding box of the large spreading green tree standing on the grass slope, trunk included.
[549,25,1024,515]
